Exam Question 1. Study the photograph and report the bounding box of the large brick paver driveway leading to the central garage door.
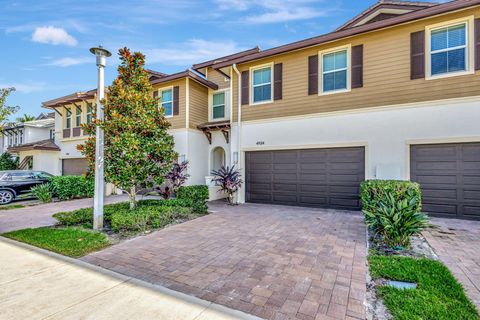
[82,203,366,320]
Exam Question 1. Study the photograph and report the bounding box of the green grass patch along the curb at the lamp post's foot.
[3,227,109,258]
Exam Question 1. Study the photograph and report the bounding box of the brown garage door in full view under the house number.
[245,147,365,210]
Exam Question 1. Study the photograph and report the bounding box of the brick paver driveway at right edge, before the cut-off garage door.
[423,218,480,310]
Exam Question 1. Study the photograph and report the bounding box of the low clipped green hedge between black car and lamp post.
[51,176,94,200]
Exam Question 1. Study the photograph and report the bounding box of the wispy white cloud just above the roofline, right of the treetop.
[143,39,245,66]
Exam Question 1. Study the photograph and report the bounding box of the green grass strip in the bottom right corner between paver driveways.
[369,255,480,320]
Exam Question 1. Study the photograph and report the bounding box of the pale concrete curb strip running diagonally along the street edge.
[0,236,262,320]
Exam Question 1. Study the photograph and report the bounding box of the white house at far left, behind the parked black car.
[2,113,60,174]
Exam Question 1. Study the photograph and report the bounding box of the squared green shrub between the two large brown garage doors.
[360,180,428,247]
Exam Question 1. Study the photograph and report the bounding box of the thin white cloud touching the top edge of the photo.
[215,0,332,24]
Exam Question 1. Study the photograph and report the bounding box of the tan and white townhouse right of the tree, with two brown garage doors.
[41,0,480,219]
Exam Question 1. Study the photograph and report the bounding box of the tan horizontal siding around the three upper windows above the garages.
[232,8,480,121]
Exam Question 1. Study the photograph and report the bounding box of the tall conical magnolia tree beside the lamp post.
[78,48,177,209]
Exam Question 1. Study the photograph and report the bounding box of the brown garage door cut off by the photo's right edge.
[410,143,480,219]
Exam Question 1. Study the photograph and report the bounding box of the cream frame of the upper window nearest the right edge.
[425,16,475,80]
